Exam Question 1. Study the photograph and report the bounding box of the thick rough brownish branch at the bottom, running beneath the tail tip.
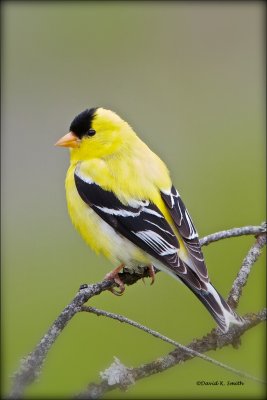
[75,309,266,399]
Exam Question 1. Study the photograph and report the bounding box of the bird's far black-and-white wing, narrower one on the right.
[161,186,209,282]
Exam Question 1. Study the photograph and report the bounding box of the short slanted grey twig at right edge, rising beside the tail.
[227,233,267,309]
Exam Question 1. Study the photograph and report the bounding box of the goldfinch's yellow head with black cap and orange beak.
[56,107,135,161]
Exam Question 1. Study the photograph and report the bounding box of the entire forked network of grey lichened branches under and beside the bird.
[9,222,266,399]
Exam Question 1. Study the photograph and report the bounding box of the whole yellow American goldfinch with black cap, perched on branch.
[56,107,242,332]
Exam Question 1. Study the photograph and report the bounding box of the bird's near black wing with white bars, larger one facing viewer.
[74,171,186,274]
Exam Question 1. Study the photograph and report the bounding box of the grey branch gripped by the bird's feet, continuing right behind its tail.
[10,223,266,398]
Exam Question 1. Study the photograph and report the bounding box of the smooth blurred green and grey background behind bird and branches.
[2,1,265,399]
